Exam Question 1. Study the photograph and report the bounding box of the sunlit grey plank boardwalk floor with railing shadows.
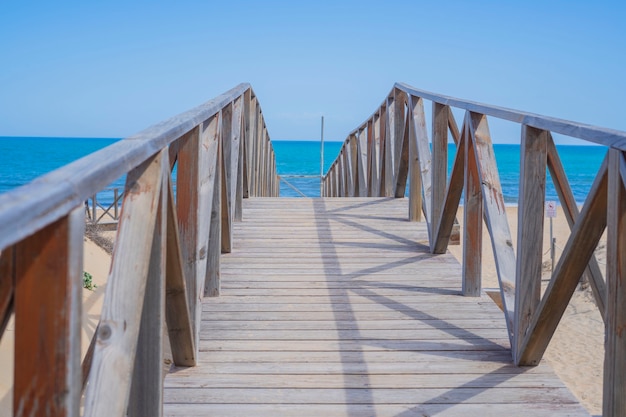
[164,198,588,417]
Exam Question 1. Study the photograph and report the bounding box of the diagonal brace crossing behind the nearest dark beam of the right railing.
[548,133,606,323]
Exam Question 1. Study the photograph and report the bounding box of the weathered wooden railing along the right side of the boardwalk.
[323,84,626,416]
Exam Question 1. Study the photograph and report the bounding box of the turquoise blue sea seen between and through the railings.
[0,136,606,209]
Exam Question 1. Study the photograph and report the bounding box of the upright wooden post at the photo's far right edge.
[602,149,626,417]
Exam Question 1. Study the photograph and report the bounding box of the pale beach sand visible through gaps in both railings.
[0,207,605,417]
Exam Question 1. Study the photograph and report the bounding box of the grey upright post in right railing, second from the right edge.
[513,125,548,357]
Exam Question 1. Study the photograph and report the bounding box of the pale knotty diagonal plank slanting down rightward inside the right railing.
[469,113,516,337]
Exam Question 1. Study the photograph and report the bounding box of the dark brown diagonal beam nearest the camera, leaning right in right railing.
[516,158,608,365]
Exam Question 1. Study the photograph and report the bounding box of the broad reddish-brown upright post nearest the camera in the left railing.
[13,204,85,416]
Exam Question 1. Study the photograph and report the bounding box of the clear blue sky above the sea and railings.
[0,0,626,142]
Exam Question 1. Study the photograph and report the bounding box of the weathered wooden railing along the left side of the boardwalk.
[0,84,278,417]
